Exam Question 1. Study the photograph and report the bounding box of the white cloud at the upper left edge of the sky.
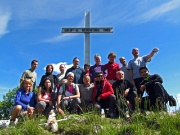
[0,10,10,37]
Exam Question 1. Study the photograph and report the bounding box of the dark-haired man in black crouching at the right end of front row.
[139,67,176,110]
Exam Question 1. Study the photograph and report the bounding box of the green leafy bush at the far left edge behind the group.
[0,87,18,119]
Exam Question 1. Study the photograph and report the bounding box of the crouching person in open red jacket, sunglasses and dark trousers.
[92,72,116,118]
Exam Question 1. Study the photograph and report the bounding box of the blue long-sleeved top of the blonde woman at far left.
[15,89,35,110]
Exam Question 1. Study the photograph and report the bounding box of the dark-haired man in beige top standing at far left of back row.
[20,60,38,91]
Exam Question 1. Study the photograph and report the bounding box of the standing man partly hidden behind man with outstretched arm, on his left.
[119,57,131,82]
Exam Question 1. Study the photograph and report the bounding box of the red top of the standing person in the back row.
[105,62,120,80]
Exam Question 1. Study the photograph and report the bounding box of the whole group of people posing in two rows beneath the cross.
[11,48,176,124]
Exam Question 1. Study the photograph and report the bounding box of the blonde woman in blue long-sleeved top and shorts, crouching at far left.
[11,78,35,125]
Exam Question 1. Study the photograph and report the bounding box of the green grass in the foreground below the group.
[0,112,180,135]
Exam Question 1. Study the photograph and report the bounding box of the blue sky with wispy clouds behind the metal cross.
[0,0,180,109]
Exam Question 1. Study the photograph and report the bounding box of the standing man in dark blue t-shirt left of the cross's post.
[65,57,85,84]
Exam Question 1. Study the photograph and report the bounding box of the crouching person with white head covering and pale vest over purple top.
[57,72,81,116]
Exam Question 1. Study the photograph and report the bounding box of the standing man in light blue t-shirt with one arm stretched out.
[128,48,159,97]
